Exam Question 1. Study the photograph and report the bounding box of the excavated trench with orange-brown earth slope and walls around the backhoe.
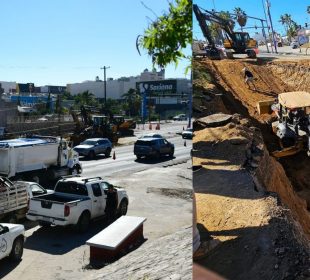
[194,59,310,243]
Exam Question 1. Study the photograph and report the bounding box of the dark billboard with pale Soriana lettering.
[136,80,177,95]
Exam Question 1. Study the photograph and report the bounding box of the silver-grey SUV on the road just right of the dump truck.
[73,138,112,159]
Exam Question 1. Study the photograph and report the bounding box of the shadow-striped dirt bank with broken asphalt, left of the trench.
[193,115,310,279]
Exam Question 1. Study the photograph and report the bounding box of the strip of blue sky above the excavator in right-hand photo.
[193,0,310,39]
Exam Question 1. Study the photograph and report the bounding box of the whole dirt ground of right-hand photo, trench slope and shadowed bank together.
[193,55,310,279]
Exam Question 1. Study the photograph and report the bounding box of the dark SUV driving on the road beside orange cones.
[134,138,174,159]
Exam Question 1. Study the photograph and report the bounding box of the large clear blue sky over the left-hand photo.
[0,0,187,86]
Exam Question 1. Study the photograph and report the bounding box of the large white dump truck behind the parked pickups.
[0,136,82,183]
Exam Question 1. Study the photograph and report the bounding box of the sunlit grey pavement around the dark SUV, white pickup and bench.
[0,122,192,280]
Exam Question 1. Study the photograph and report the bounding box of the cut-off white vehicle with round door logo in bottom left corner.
[0,224,25,261]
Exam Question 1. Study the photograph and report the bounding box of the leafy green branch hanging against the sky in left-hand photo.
[137,0,192,68]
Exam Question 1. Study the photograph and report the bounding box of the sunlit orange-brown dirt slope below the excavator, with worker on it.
[203,59,291,122]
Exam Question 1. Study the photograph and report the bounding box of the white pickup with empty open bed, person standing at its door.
[26,175,128,232]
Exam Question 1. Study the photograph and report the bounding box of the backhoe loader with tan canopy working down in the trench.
[272,91,310,157]
